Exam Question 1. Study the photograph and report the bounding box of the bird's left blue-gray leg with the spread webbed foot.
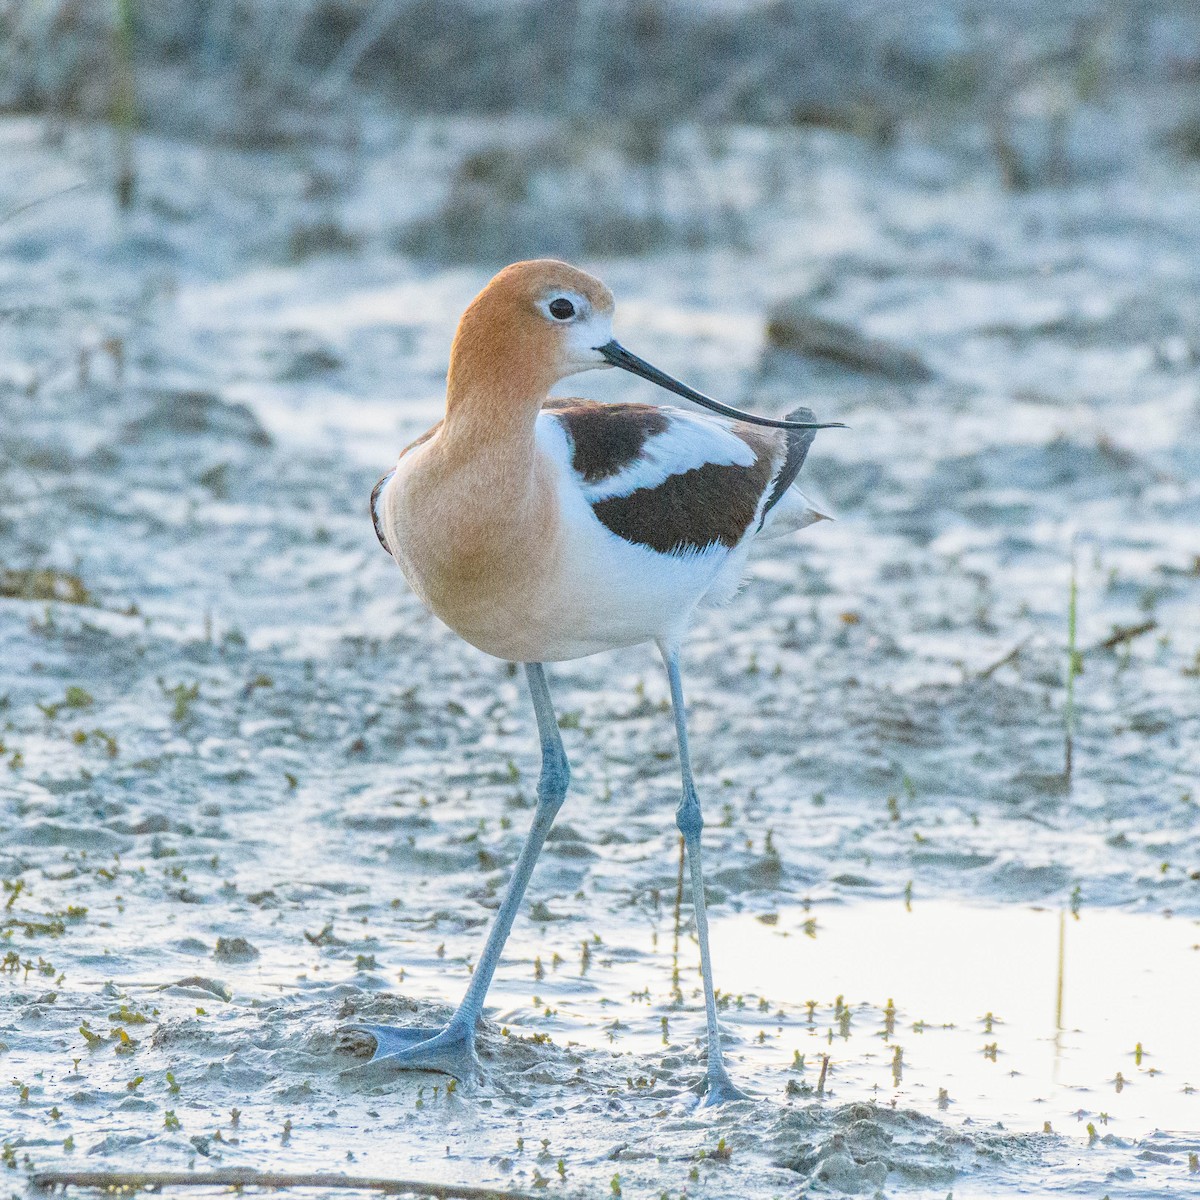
[349,662,571,1079]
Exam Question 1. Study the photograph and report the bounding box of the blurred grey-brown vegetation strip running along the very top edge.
[0,0,1200,140]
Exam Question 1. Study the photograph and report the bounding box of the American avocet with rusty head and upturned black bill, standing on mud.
[354,260,840,1103]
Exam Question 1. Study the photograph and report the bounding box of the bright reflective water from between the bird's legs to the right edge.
[480,901,1200,1136]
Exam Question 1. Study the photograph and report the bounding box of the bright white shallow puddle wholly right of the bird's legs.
[716,901,1200,1138]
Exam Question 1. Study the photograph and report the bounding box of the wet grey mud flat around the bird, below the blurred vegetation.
[0,91,1200,1200]
